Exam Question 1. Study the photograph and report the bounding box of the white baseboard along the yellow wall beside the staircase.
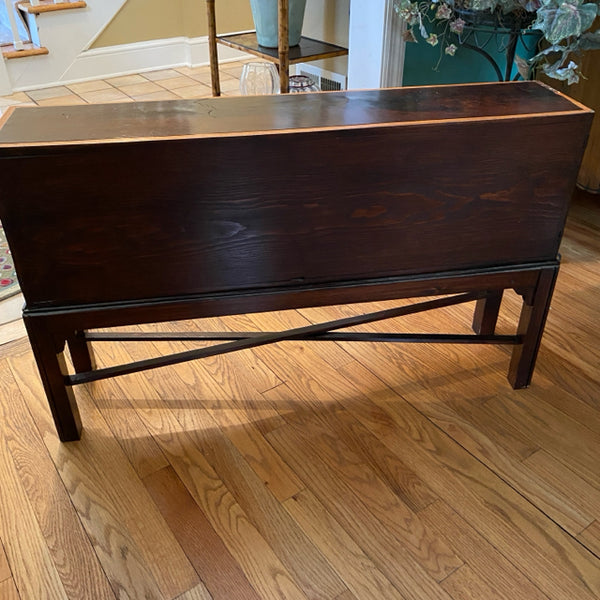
[14,36,249,91]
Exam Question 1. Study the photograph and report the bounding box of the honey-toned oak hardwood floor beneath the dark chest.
[0,194,600,600]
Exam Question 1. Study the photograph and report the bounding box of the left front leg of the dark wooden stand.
[24,317,81,442]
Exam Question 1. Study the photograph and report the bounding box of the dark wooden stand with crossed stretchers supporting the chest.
[24,263,558,442]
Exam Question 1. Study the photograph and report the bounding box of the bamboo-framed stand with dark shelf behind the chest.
[206,0,348,96]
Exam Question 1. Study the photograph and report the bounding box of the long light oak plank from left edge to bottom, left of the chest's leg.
[0,364,114,600]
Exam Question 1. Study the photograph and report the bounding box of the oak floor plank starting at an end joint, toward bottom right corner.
[419,501,547,600]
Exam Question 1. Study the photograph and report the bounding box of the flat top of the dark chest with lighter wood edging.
[0,81,591,148]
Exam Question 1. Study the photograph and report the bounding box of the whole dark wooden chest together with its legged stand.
[0,82,592,440]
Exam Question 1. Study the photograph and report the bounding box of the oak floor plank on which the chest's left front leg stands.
[11,357,198,598]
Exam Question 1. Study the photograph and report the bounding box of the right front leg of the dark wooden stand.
[508,266,558,390]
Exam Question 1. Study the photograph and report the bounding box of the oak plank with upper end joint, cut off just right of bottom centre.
[284,490,405,600]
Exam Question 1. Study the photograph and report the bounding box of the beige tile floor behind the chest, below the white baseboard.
[0,61,245,113]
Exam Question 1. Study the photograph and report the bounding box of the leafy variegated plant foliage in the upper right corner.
[394,0,600,84]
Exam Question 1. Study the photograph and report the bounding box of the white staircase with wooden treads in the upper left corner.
[0,0,127,95]
